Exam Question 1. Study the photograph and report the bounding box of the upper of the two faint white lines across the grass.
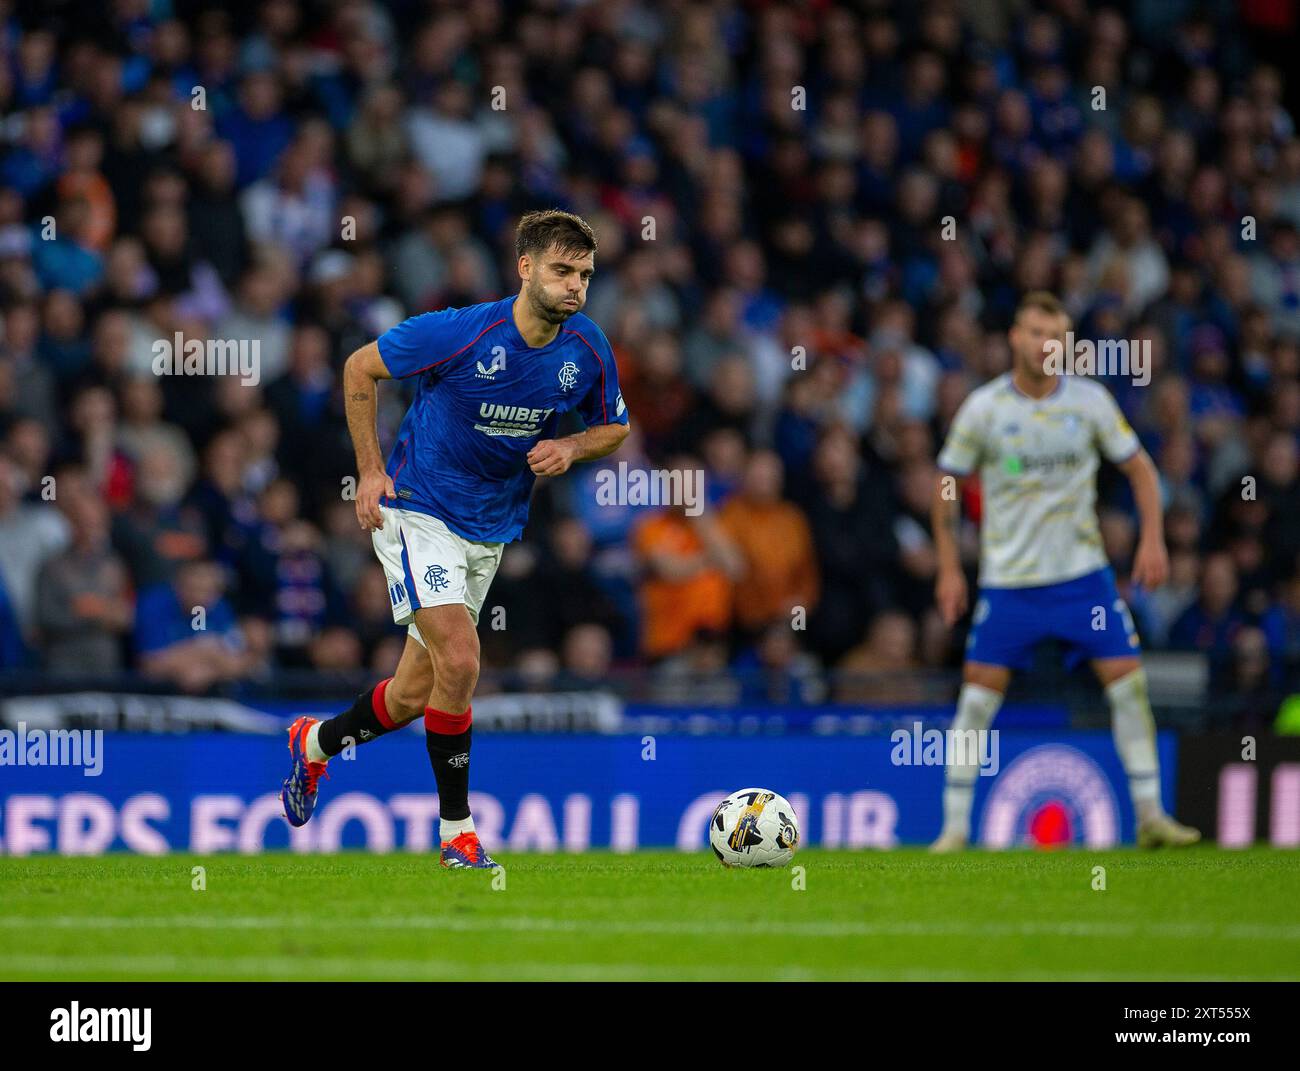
[0,915,1300,941]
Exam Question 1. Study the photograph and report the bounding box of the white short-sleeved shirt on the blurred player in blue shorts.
[939,373,1140,587]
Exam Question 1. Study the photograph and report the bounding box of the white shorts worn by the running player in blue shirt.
[371,506,506,645]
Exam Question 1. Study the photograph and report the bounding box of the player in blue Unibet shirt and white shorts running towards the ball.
[281,211,628,868]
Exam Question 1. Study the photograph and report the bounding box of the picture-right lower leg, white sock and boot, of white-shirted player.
[1092,655,1201,847]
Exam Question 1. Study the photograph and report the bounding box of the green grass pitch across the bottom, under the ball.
[0,847,1300,981]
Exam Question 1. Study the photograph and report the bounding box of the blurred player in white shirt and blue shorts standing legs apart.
[931,292,1200,851]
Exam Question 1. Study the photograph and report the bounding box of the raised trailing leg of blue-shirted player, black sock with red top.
[280,636,433,825]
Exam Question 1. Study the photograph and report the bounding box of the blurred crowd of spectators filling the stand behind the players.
[0,0,1300,716]
